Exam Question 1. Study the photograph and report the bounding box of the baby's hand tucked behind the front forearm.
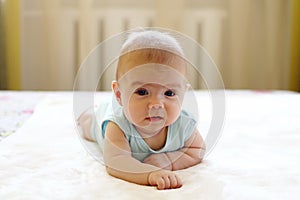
[143,153,172,170]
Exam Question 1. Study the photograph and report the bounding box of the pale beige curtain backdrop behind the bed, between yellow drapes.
[8,0,297,90]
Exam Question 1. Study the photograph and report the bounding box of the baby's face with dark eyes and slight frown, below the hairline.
[118,63,188,137]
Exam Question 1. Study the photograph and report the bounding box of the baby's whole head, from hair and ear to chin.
[112,31,188,135]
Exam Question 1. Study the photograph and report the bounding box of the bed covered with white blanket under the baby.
[0,90,300,200]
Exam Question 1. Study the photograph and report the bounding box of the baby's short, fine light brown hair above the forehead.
[116,30,184,79]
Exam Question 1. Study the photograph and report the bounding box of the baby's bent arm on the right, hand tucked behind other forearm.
[144,130,205,170]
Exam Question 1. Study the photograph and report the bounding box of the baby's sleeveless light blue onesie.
[92,98,197,162]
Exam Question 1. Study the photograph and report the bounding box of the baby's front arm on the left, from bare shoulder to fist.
[104,122,182,189]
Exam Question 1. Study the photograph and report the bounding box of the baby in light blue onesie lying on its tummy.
[78,30,205,189]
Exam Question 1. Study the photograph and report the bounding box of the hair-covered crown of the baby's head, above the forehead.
[116,31,186,80]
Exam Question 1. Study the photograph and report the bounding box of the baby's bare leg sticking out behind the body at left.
[77,107,95,142]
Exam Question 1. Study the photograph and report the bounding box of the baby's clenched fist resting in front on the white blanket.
[148,170,182,190]
